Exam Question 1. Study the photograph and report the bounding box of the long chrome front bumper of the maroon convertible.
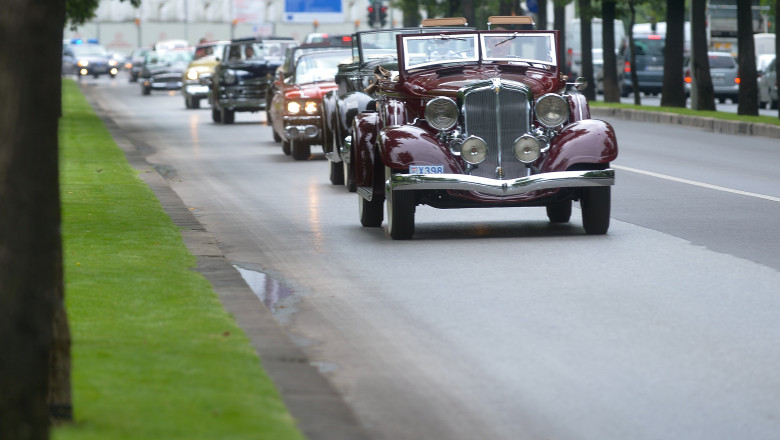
[386,169,615,196]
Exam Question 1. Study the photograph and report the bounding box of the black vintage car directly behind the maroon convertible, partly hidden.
[322,18,473,192]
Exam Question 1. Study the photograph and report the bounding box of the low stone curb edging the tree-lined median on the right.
[590,107,780,139]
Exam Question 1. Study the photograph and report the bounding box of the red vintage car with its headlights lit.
[268,49,352,160]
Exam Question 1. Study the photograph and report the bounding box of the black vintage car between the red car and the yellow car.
[209,37,298,124]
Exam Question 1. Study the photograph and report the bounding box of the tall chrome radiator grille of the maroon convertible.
[463,83,530,179]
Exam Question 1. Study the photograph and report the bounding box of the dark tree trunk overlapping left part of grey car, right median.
[685,0,715,110]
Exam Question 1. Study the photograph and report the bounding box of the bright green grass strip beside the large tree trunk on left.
[53,80,303,440]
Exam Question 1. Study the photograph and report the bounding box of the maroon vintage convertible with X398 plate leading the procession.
[349,17,618,239]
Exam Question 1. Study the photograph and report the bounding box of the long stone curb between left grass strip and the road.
[81,88,370,440]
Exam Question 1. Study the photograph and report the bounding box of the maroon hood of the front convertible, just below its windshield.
[400,66,565,98]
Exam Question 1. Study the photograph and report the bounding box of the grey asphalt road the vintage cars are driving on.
[82,75,780,440]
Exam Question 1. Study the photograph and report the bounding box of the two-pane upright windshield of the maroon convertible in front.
[403,32,556,70]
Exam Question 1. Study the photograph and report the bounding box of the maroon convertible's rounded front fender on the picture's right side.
[540,119,618,172]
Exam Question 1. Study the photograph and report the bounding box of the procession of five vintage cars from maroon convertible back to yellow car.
[174,17,618,240]
